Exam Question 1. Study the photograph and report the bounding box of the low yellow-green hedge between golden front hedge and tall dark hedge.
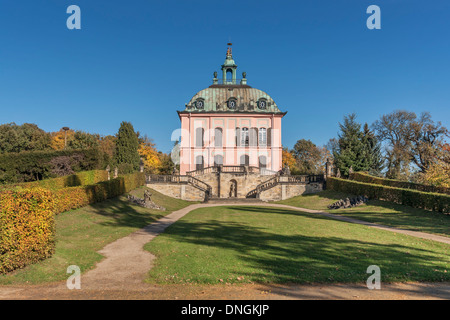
[0,170,108,190]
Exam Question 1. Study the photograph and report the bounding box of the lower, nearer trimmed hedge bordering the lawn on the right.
[327,177,450,213]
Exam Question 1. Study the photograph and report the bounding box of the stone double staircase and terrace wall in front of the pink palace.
[147,166,323,203]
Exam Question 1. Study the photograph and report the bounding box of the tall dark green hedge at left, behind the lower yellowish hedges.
[0,148,105,184]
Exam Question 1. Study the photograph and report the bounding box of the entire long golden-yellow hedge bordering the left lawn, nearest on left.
[0,172,145,274]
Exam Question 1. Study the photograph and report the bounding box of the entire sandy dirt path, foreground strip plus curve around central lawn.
[0,203,450,300]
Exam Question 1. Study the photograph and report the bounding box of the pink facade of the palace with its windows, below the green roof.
[180,113,283,175]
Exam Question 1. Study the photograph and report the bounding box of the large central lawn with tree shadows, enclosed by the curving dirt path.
[145,206,450,284]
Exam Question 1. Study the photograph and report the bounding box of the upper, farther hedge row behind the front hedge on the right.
[349,172,450,194]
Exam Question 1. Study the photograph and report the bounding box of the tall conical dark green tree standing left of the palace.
[114,121,140,173]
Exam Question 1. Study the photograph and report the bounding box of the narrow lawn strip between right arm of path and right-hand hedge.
[276,191,450,237]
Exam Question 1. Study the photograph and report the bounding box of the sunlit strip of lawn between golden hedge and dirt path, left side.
[0,187,192,284]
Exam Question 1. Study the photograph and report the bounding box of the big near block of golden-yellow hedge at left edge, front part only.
[0,188,55,274]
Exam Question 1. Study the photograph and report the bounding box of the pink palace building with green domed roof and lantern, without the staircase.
[178,43,286,175]
